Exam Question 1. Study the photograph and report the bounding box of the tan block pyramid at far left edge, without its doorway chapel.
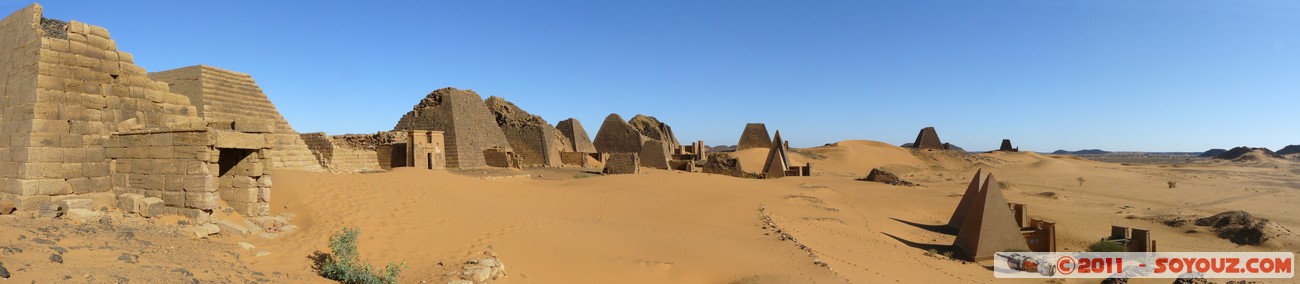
[0,4,205,210]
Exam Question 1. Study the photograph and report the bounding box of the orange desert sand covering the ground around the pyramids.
[0,141,1300,283]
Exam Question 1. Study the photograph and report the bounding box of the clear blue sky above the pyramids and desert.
[12,0,1300,151]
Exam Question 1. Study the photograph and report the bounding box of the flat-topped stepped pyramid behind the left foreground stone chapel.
[148,65,324,171]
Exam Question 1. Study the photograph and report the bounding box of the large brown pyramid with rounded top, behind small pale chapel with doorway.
[393,87,514,168]
